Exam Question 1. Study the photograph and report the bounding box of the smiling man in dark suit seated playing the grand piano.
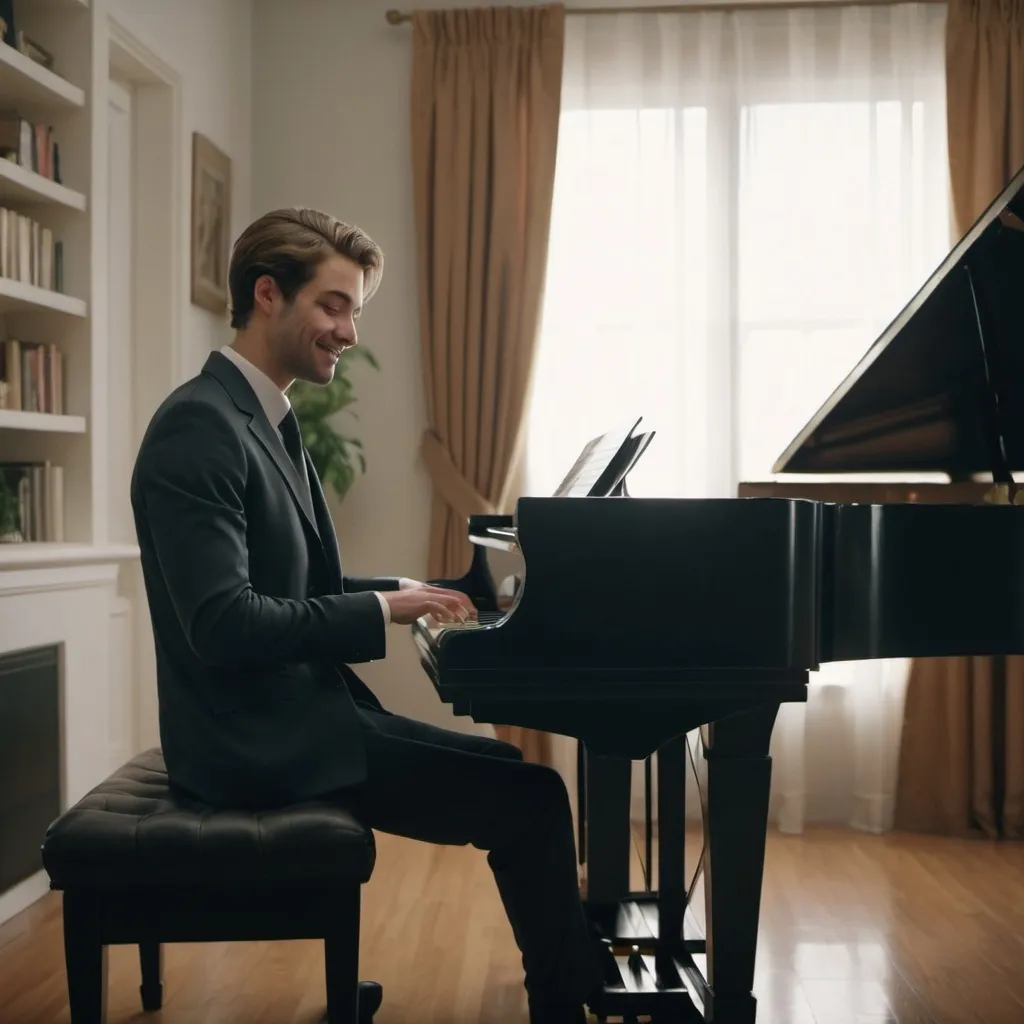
[131,209,601,1024]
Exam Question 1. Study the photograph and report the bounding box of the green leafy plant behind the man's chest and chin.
[288,345,380,498]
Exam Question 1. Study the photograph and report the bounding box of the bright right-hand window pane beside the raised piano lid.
[735,100,949,479]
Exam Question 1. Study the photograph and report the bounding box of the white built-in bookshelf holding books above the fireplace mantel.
[0,0,96,571]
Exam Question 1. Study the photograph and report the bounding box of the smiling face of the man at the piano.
[269,255,362,384]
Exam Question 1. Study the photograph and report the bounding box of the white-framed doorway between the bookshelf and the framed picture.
[106,17,184,755]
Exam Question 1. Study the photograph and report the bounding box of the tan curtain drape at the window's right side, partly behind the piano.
[895,0,1024,839]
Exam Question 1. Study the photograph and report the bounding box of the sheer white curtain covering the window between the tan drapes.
[525,4,950,831]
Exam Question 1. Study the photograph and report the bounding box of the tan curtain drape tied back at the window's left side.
[412,4,565,760]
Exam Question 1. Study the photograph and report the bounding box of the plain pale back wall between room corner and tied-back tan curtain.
[253,0,512,729]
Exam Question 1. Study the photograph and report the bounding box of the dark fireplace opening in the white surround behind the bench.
[0,644,61,893]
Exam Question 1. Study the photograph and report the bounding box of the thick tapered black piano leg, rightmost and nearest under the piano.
[702,703,778,1024]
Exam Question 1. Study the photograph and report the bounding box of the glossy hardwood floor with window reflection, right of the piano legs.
[635,822,1024,1024]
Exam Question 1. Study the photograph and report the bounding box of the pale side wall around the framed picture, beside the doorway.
[106,0,252,377]
